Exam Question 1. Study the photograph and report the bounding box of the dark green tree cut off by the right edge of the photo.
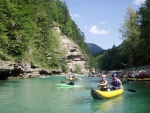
[138,0,150,64]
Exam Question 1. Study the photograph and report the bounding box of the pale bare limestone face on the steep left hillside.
[59,36,88,73]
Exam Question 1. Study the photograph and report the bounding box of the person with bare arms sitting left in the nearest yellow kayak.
[97,75,108,91]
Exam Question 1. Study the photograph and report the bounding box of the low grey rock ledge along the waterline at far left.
[0,61,51,80]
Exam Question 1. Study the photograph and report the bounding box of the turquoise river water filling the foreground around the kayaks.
[0,76,150,113]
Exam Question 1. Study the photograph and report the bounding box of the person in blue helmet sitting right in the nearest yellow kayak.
[111,74,122,90]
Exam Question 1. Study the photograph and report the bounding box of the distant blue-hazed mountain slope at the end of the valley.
[87,43,103,56]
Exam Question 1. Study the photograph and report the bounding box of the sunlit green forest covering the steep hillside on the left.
[0,0,89,71]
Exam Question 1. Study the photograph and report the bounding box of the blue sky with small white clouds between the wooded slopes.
[62,0,145,49]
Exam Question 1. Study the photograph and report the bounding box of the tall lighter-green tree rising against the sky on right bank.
[119,7,140,66]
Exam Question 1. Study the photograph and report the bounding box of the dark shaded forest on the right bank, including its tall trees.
[94,0,150,70]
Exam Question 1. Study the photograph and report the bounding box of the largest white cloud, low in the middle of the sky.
[89,26,109,35]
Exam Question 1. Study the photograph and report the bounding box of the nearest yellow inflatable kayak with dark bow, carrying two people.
[91,88,124,99]
